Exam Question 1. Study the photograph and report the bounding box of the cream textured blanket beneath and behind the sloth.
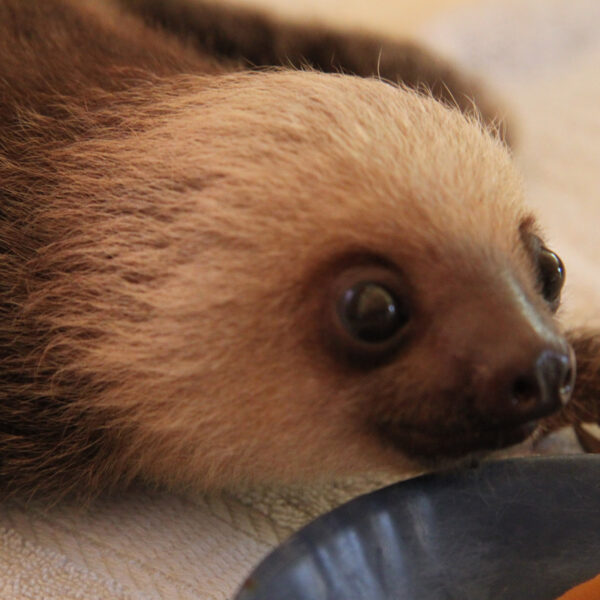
[0,0,600,600]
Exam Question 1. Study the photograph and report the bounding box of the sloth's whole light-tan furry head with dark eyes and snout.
[16,73,575,494]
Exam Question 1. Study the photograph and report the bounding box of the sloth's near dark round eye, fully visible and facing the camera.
[338,281,408,344]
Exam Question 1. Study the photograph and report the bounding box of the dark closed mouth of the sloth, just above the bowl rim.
[380,421,537,461]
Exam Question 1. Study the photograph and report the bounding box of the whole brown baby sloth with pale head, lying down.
[0,0,593,495]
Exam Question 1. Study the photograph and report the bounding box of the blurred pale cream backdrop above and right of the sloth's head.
[241,0,600,325]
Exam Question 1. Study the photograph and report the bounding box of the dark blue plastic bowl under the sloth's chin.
[236,456,600,600]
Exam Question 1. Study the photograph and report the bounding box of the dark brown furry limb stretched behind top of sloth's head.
[117,0,504,135]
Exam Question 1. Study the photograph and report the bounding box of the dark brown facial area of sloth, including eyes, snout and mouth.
[326,230,575,459]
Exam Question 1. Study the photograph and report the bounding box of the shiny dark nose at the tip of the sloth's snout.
[486,346,575,425]
